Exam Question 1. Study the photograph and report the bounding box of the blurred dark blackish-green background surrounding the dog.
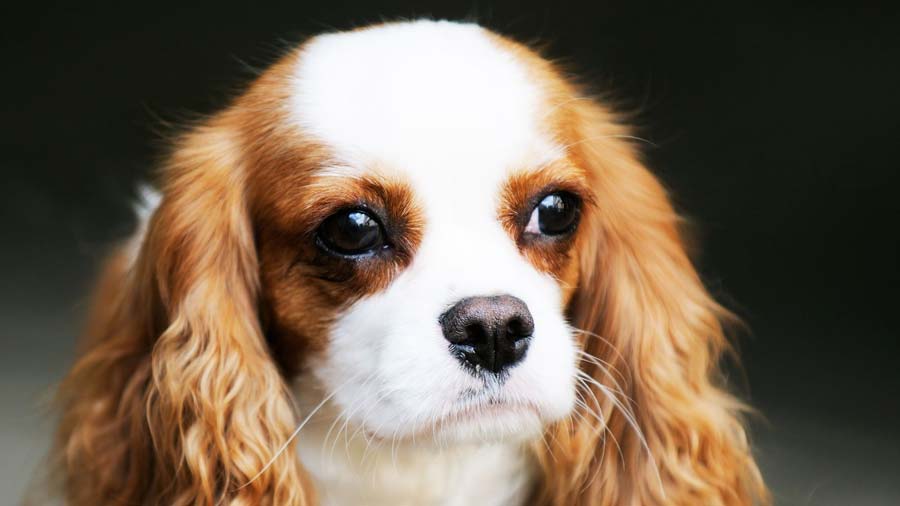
[0,0,900,505]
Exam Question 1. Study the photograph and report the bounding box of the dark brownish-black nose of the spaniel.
[439,295,534,373]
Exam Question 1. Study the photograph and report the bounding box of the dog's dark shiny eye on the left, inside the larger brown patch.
[318,209,384,255]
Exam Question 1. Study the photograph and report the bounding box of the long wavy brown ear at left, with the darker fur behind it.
[57,120,313,505]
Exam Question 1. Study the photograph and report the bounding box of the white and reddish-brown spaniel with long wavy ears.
[56,21,767,506]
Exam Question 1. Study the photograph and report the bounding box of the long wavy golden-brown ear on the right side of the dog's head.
[538,102,768,506]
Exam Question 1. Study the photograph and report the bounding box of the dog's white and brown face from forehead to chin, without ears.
[251,23,590,439]
